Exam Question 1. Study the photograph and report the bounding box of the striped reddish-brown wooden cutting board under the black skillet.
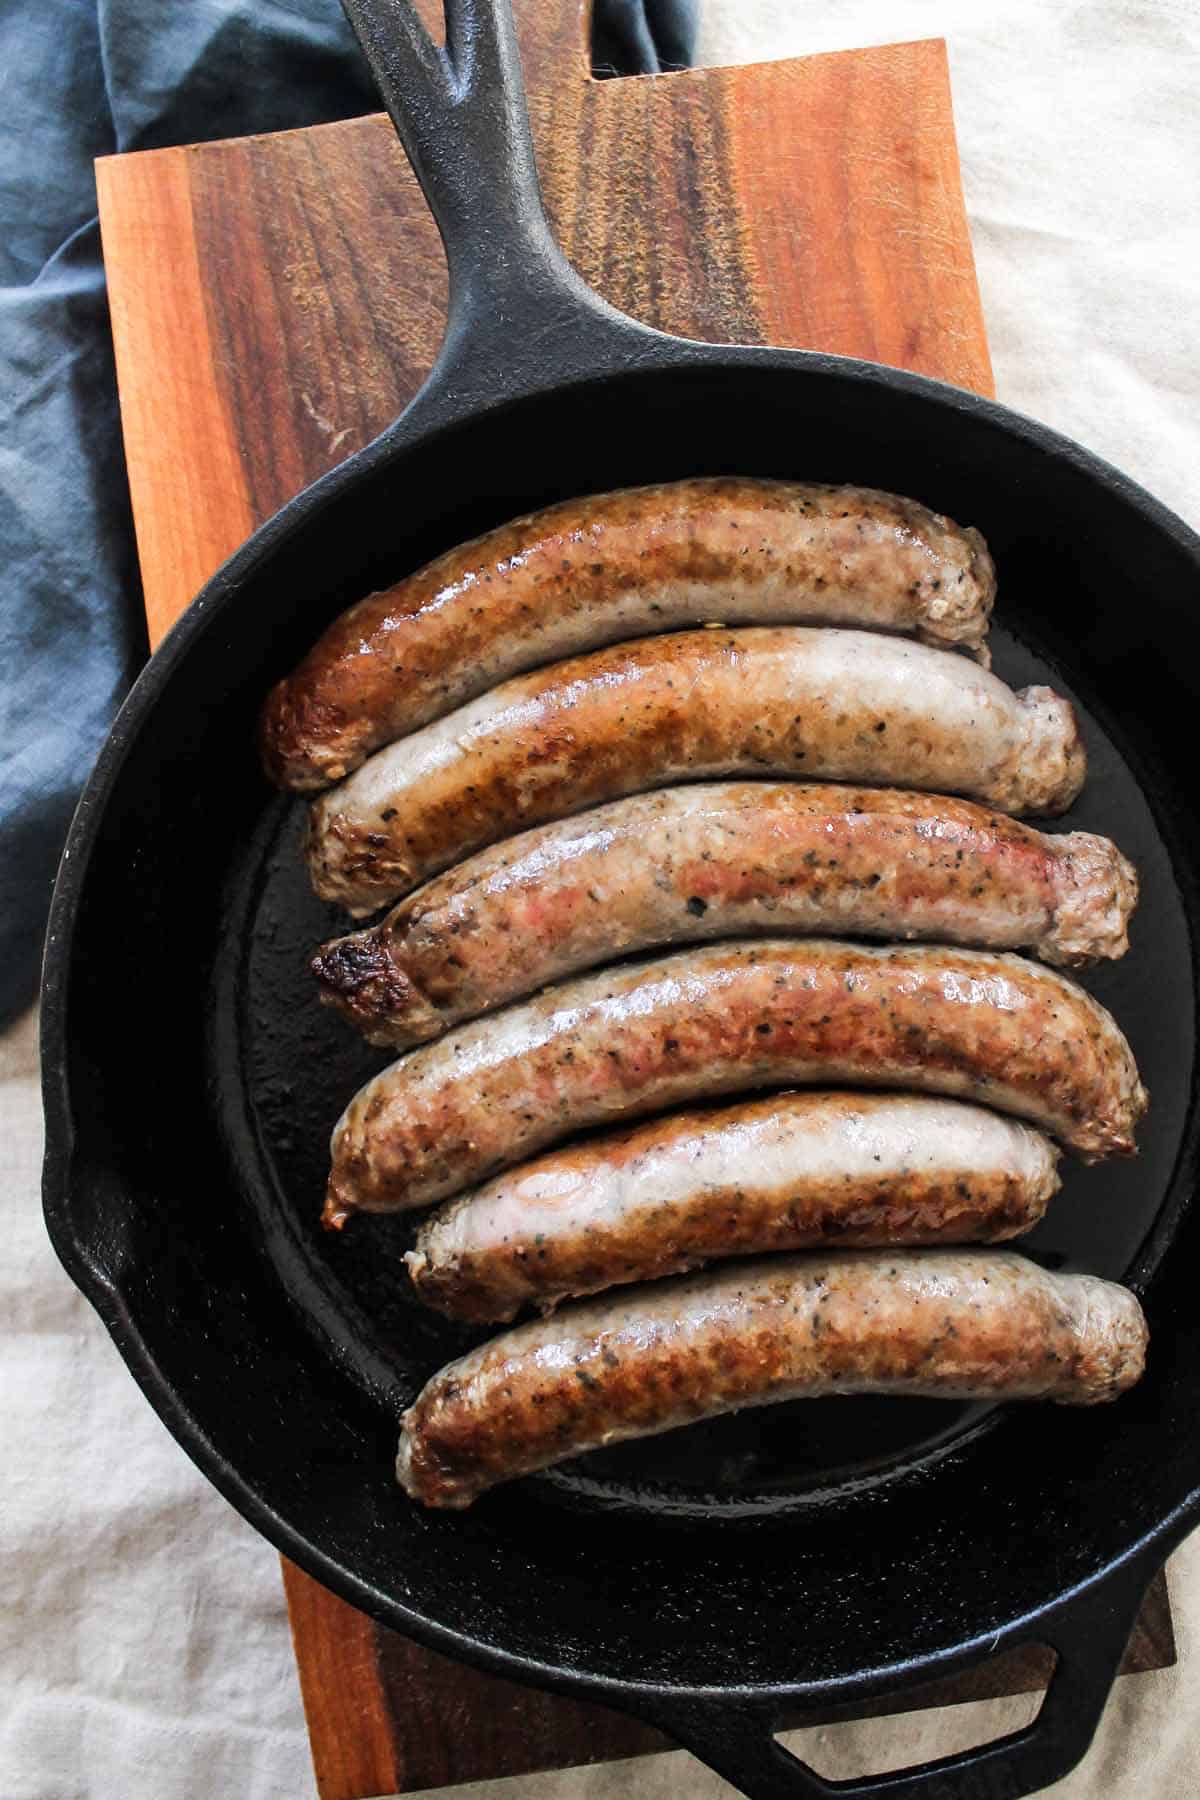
[97,0,1175,1800]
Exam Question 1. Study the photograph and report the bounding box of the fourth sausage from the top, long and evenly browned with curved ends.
[326,938,1146,1226]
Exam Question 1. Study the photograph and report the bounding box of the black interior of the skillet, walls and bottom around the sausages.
[51,353,1200,1685]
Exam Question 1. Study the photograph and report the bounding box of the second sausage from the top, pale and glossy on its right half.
[308,626,1085,914]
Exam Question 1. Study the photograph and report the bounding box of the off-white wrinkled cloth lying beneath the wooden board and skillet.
[0,0,1200,1800]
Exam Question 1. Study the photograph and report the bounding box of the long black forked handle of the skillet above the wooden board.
[342,0,658,412]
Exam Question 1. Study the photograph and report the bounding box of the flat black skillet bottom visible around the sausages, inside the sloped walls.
[223,615,1195,1514]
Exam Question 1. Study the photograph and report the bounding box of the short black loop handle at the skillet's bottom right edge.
[642,1557,1159,1800]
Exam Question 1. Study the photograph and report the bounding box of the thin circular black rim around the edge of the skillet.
[40,333,1200,1715]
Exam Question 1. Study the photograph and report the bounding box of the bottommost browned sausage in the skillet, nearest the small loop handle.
[396,1249,1146,1507]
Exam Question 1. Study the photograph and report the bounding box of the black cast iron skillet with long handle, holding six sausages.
[43,0,1200,1800]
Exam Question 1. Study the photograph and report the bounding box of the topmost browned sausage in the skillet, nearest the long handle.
[261,477,995,788]
